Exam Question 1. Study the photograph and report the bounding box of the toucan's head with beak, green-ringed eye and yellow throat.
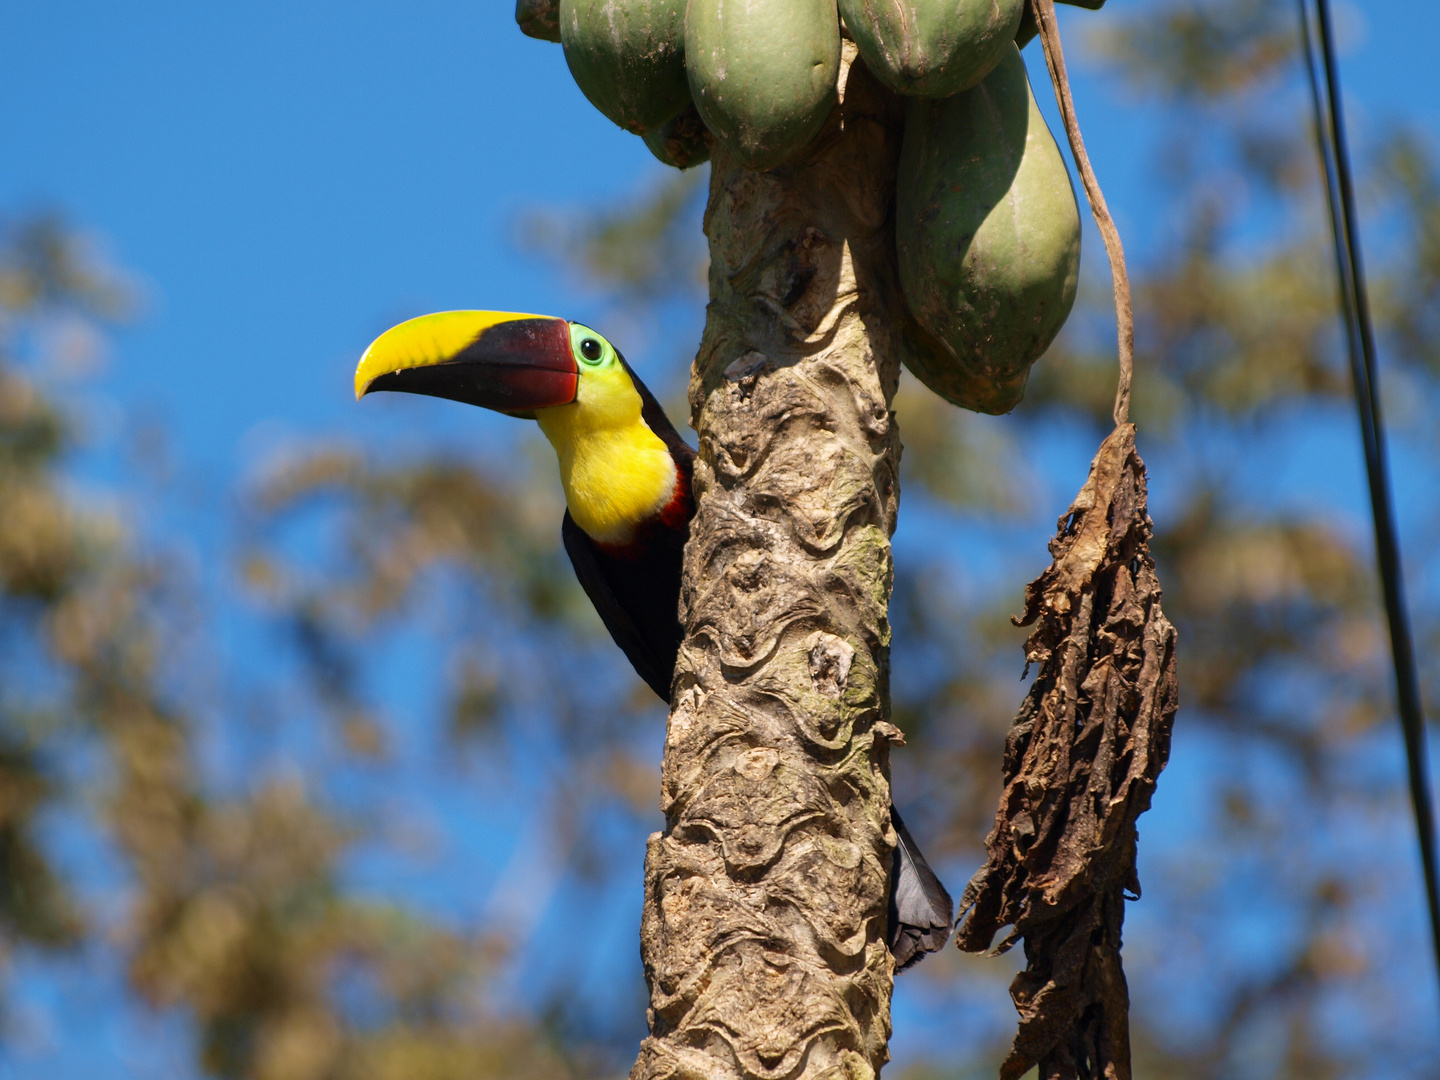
[356,311,677,541]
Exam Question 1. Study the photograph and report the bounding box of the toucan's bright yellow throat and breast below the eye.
[536,361,677,544]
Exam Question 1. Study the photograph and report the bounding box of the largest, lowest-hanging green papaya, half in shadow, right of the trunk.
[896,45,1080,412]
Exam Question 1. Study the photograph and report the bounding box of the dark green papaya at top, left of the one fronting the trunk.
[560,0,690,135]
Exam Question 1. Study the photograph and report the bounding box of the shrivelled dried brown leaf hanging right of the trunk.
[956,423,1178,1080]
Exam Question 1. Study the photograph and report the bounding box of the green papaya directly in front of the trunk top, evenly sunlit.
[685,0,840,168]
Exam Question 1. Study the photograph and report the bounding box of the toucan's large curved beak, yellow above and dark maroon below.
[356,311,580,415]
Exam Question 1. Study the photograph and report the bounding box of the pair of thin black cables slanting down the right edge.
[1299,0,1440,975]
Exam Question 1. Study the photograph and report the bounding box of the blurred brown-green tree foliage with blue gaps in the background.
[0,0,1440,1080]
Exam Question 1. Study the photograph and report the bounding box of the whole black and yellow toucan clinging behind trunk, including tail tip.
[356,311,955,971]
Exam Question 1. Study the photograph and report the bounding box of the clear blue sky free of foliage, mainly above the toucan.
[0,0,1440,1076]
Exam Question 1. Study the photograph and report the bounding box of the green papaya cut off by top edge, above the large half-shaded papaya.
[840,0,1025,98]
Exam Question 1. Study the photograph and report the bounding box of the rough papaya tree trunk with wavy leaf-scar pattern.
[631,42,906,1080]
